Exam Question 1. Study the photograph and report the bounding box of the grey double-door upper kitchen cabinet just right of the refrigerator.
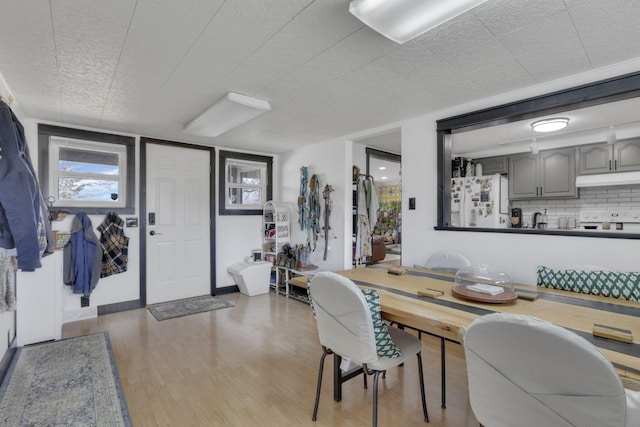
[509,147,578,200]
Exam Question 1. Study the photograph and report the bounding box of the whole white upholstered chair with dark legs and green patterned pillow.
[309,272,429,427]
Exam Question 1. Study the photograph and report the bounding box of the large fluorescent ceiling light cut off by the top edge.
[349,0,486,44]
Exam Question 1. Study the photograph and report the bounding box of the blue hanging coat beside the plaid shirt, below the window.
[64,212,102,297]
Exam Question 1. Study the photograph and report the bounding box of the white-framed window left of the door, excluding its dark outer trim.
[49,137,127,207]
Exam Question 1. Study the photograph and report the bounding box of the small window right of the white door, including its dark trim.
[220,151,272,215]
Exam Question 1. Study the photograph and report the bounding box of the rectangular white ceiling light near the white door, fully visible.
[183,92,271,137]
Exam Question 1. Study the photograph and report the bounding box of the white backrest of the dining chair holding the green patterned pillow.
[309,271,378,364]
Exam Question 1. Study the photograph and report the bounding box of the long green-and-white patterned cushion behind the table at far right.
[538,266,640,302]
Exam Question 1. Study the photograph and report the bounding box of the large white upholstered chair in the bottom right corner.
[463,313,640,427]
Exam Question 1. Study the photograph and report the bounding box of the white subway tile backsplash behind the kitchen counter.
[511,186,640,228]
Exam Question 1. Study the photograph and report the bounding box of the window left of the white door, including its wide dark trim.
[38,124,135,214]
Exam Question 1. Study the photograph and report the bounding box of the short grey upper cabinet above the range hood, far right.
[578,138,640,175]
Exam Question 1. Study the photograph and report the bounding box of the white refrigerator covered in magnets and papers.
[449,174,509,228]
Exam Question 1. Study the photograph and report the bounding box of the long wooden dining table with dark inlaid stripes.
[292,266,640,407]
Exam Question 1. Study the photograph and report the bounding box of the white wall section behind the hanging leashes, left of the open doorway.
[278,139,353,270]
